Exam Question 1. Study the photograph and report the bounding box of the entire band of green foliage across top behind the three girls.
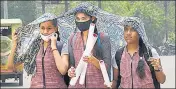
[1,0,175,45]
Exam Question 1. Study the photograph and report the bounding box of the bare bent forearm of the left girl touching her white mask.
[53,50,68,75]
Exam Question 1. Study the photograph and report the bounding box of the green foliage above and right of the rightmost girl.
[99,1,175,45]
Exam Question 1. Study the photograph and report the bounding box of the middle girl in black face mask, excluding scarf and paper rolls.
[68,8,111,88]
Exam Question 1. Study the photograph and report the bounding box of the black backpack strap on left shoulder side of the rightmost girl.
[115,47,125,88]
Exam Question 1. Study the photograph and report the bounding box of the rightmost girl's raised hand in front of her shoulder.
[149,58,161,70]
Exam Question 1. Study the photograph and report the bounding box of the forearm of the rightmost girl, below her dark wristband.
[155,71,166,84]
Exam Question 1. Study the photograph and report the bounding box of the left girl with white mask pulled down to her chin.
[8,13,68,88]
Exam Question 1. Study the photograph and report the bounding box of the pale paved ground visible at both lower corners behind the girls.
[1,56,175,88]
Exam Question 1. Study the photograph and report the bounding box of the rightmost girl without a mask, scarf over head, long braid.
[114,17,166,89]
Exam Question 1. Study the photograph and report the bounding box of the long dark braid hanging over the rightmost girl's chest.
[136,37,148,79]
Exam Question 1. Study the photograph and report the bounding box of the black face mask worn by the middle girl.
[76,20,92,32]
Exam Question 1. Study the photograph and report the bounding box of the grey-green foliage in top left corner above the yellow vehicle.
[8,1,36,25]
